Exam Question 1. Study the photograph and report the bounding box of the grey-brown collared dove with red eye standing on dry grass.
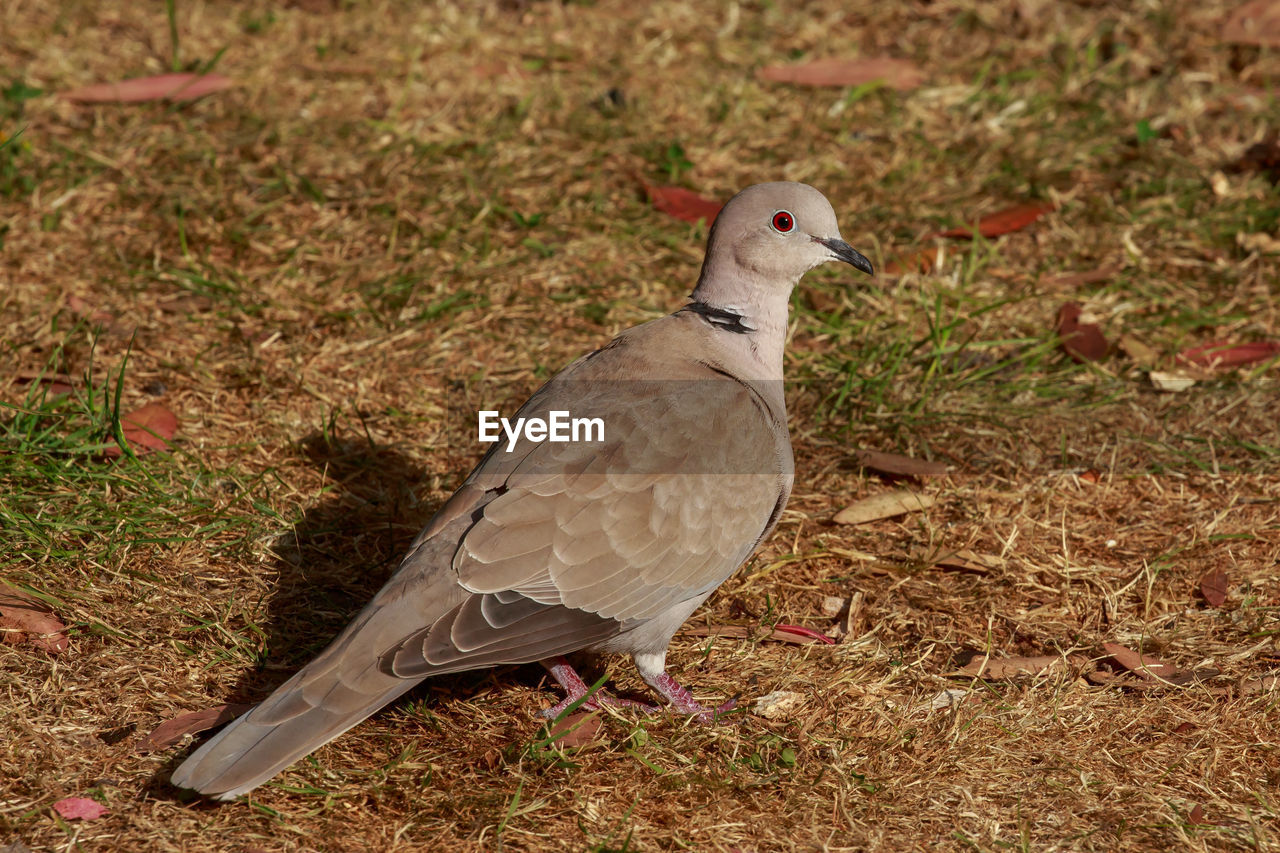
[173,183,872,799]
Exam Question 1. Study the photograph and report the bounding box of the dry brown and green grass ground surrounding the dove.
[0,0,1280,852]
